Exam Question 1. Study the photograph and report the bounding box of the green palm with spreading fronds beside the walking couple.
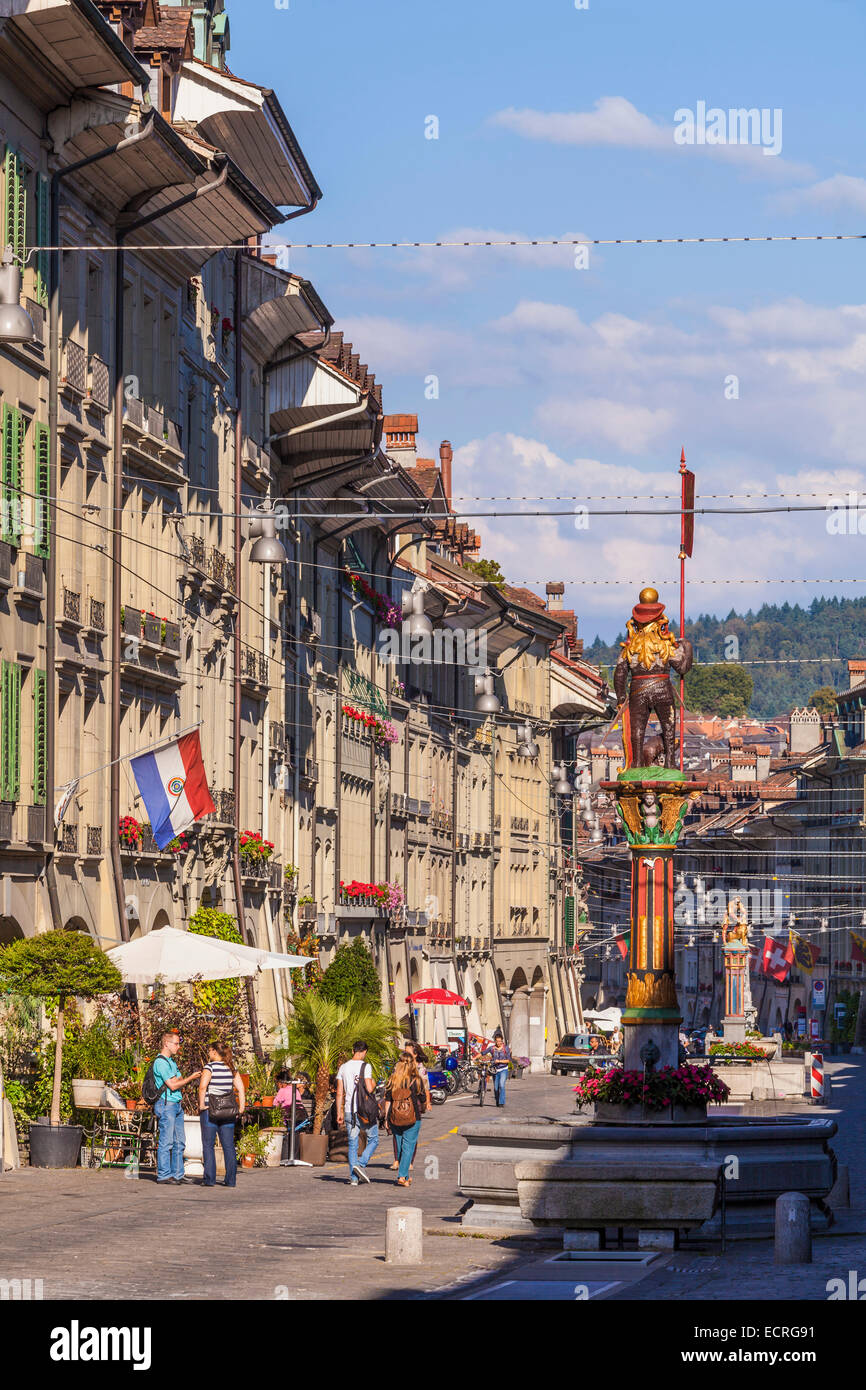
[286,992,400,1134]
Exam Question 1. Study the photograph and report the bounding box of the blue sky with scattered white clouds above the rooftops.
[227,0,866,641]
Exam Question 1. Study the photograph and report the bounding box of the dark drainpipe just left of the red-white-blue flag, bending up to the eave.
[108,161,228,941]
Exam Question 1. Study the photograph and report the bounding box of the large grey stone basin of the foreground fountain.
[459,1115,837,1240]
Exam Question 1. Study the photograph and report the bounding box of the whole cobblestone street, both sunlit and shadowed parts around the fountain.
[0,1058,866,1301]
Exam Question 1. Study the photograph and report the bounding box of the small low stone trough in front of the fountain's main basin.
[514,1154,723,1247]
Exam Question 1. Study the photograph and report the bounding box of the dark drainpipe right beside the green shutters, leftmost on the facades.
[44,111,153,941]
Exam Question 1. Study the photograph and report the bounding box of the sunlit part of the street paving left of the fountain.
[0,1076,573,1300]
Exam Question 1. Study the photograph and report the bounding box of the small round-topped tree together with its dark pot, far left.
[0,931,124,1168]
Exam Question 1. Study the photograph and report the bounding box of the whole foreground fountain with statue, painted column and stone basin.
[459,589,837,1248]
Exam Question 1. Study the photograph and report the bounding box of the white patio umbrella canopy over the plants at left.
[106,927,311,984]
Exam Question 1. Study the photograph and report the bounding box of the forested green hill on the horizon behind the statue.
[584,598,866,719]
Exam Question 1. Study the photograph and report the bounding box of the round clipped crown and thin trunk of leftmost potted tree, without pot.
[0,931,124,1125]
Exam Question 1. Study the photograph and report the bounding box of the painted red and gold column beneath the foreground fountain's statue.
[602,766,706,1072]
